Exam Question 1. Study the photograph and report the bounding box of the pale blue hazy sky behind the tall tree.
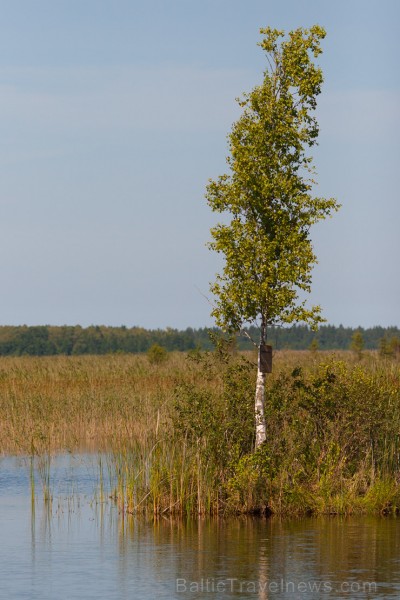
[0,0,400,329]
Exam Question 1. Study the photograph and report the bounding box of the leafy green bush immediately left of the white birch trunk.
[173,339,254,477]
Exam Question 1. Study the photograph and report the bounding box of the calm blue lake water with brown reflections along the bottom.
[0,455,400,600]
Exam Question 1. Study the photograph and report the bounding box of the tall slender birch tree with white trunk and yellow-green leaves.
[206,25,338,447]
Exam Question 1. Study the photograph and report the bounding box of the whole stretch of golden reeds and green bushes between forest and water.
[0,349,400,514]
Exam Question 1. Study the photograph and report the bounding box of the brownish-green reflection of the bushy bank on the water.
[112,518,400,599]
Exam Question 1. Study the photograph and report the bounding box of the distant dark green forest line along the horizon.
[0,325,400,356]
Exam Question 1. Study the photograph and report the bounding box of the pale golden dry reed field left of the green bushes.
[0,354,198,454]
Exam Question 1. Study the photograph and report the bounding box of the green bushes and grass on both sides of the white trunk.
[168,352,400,514]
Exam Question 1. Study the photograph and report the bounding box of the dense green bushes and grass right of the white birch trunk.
[260,361,400,512]
